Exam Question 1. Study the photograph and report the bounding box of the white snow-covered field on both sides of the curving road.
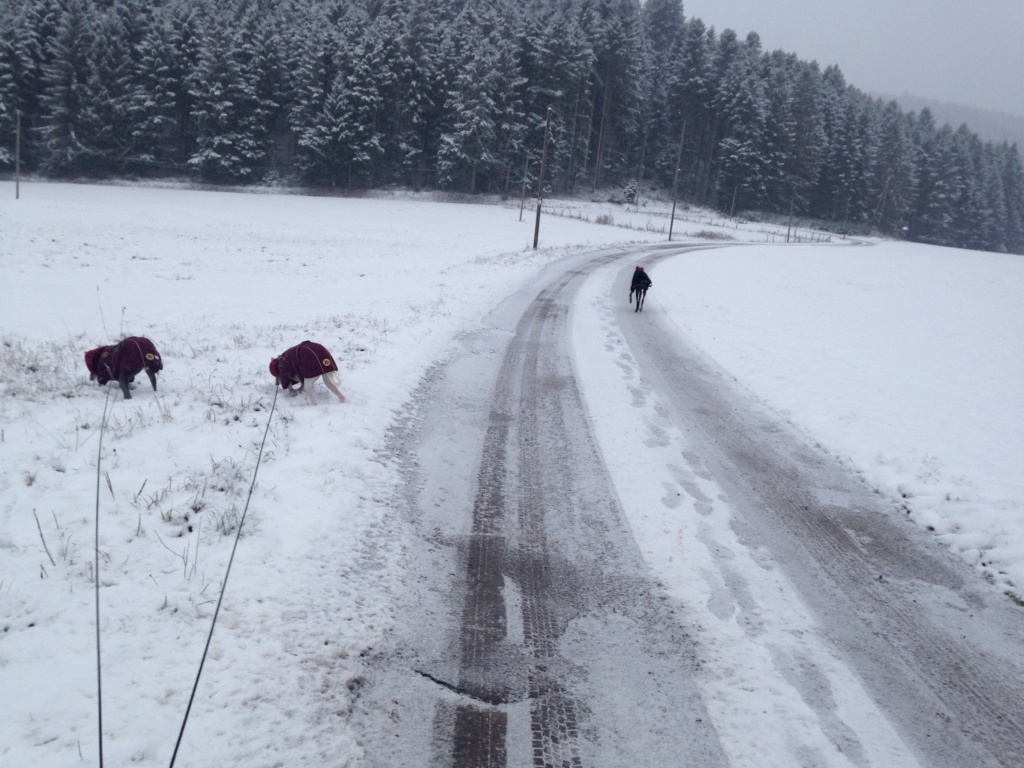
[0,182,1024,766]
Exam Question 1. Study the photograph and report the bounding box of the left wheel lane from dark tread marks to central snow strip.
[450,249,725,768]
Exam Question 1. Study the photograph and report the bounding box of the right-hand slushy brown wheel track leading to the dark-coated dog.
[622,249,1024,768]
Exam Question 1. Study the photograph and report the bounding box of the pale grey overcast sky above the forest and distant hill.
[683,0,1024,117]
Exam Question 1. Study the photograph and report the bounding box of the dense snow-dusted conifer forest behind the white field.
[0,0,1024,254]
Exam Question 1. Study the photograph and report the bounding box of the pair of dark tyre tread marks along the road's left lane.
[453,275,598,768]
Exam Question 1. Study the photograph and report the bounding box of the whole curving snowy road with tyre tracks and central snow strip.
[356,247,1024,767]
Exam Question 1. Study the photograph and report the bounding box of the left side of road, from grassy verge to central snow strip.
[358,249,726,768]
